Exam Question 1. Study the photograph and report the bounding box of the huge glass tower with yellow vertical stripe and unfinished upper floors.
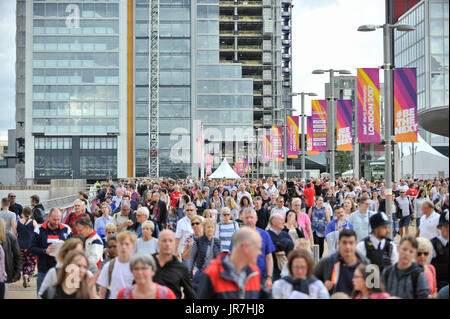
[16,0,292,181]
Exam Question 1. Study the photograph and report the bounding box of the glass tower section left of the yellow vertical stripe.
[25,0,121,179]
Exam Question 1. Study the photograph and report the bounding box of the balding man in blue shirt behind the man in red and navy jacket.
[230,207,275,290]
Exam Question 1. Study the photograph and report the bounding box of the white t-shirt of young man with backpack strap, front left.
[97,258,133,299]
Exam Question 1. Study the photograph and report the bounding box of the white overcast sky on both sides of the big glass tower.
[0,0,385,131]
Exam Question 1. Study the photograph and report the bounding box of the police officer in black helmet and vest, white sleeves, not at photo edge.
[356,212,398,274]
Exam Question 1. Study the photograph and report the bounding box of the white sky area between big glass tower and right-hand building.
[292,0,385,120]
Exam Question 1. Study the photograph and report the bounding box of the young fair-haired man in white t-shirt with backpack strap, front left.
[97,231,137,299]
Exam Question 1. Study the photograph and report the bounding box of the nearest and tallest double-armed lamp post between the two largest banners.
[358,23,415,238]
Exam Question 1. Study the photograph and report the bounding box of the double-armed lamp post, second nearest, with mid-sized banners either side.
[312,69,351,188]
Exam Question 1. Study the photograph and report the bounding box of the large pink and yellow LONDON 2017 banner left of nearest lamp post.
[357,68,381,143]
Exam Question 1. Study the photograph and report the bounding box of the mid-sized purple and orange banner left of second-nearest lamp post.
[311,100,328,152]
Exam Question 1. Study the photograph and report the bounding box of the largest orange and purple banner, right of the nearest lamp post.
[394,68,417,143]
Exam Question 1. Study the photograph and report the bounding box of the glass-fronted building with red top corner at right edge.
[394,0,449,156]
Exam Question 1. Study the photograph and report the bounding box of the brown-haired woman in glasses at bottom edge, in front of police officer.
[352,265,390,299]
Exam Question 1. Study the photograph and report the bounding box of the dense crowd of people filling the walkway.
[0,177,450,299]
